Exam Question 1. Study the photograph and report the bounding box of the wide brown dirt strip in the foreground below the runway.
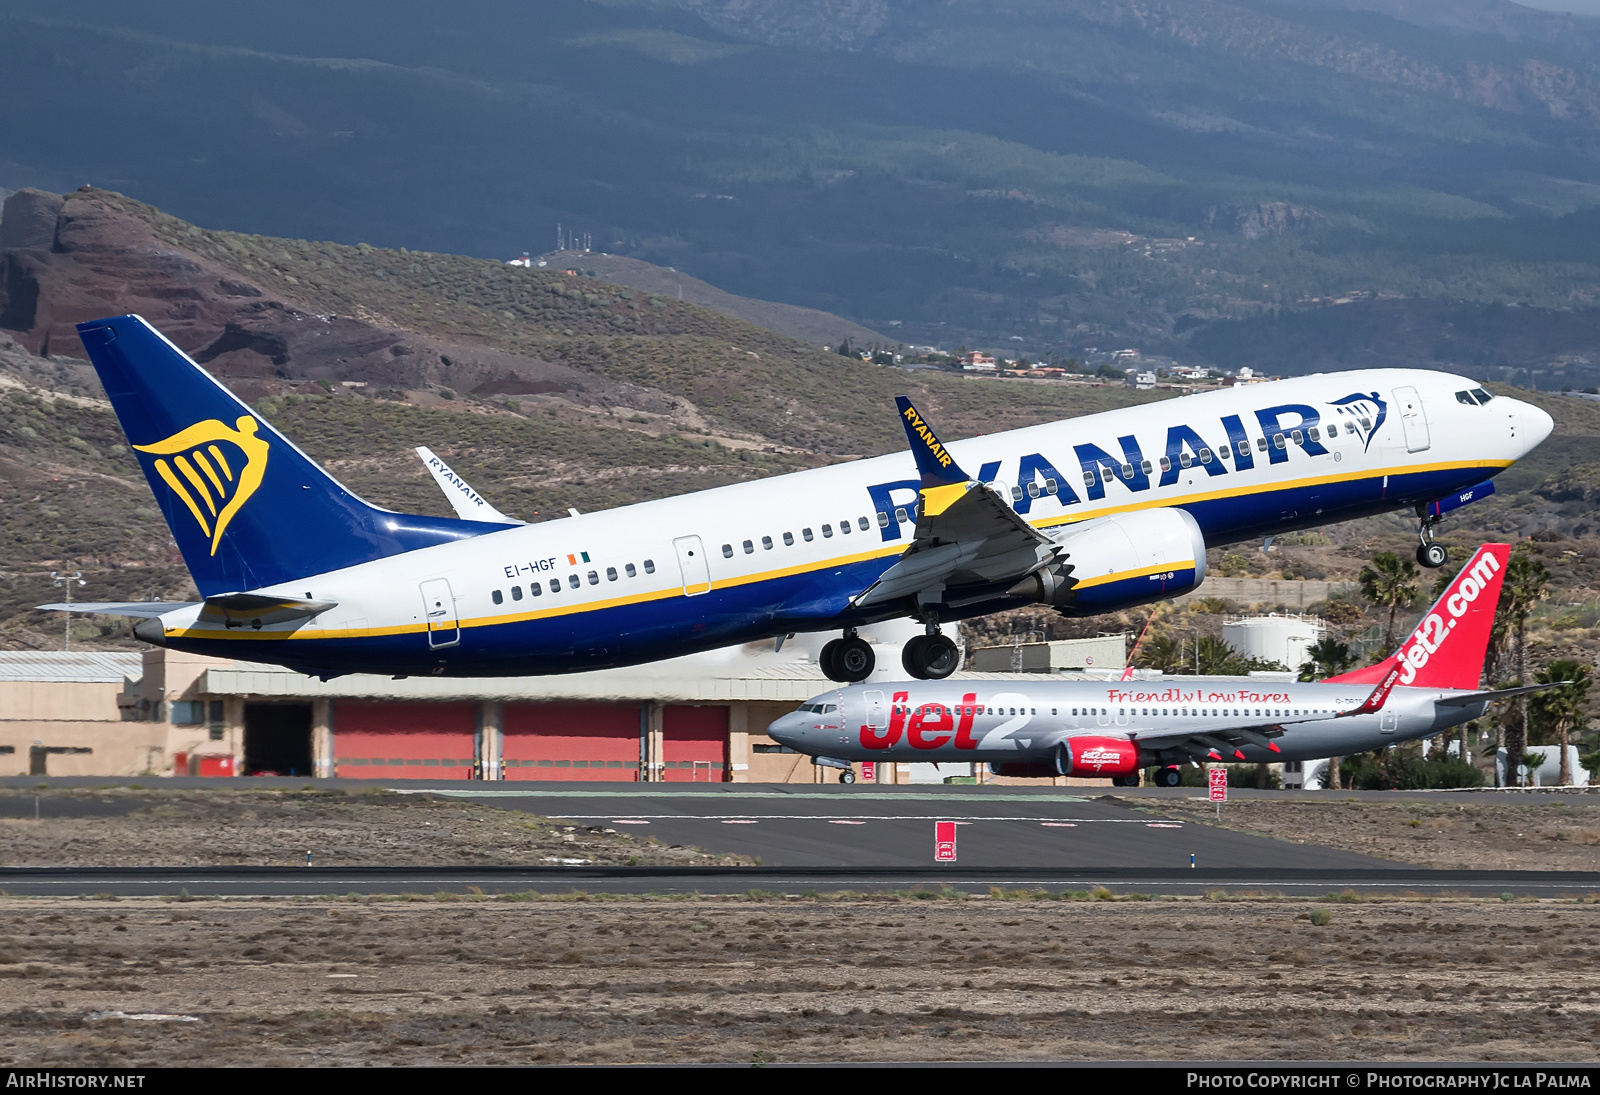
[0,895,1600,1066]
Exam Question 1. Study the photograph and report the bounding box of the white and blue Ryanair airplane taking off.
[46,315,1552,680]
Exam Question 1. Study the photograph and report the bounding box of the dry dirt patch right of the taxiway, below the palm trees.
[1125,791,1600,871]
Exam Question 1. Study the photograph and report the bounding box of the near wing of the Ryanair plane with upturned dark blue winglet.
[851,395,1058,607]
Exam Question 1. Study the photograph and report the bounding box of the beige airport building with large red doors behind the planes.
[0,636,1123,784]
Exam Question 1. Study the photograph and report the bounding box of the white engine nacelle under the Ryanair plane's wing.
[1010,507,1205,616]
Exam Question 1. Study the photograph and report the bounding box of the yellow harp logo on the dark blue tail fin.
[134,415,270,556]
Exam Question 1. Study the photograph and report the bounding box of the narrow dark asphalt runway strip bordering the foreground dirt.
[0,863,1600,900]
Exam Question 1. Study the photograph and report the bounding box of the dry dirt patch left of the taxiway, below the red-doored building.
[0,788,754,866]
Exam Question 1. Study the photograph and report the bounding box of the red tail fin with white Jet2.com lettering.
[1328,544,1510,691]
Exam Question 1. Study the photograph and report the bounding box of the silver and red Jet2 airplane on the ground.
[766,544,1554,788]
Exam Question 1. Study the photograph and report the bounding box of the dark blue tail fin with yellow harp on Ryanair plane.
[78,315,506,597]
